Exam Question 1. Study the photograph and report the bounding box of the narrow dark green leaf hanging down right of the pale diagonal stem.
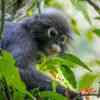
[60,65,77,89]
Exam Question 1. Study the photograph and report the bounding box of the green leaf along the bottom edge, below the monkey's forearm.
[40,91,68,100]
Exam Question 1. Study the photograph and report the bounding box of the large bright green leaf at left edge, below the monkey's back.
[0,50,25,91]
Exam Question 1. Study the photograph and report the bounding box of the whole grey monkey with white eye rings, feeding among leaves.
[0,9,81,100]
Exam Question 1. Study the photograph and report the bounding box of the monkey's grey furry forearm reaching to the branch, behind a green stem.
[20,65,78,100]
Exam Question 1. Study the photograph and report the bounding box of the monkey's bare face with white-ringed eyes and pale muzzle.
[44,27,68,55]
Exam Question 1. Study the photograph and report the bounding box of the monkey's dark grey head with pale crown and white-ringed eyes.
[26,9,71,54]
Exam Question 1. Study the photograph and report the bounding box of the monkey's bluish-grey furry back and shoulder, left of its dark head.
[0,22,36,65]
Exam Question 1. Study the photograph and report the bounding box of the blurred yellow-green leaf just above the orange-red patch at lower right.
[79,73,98,90]
